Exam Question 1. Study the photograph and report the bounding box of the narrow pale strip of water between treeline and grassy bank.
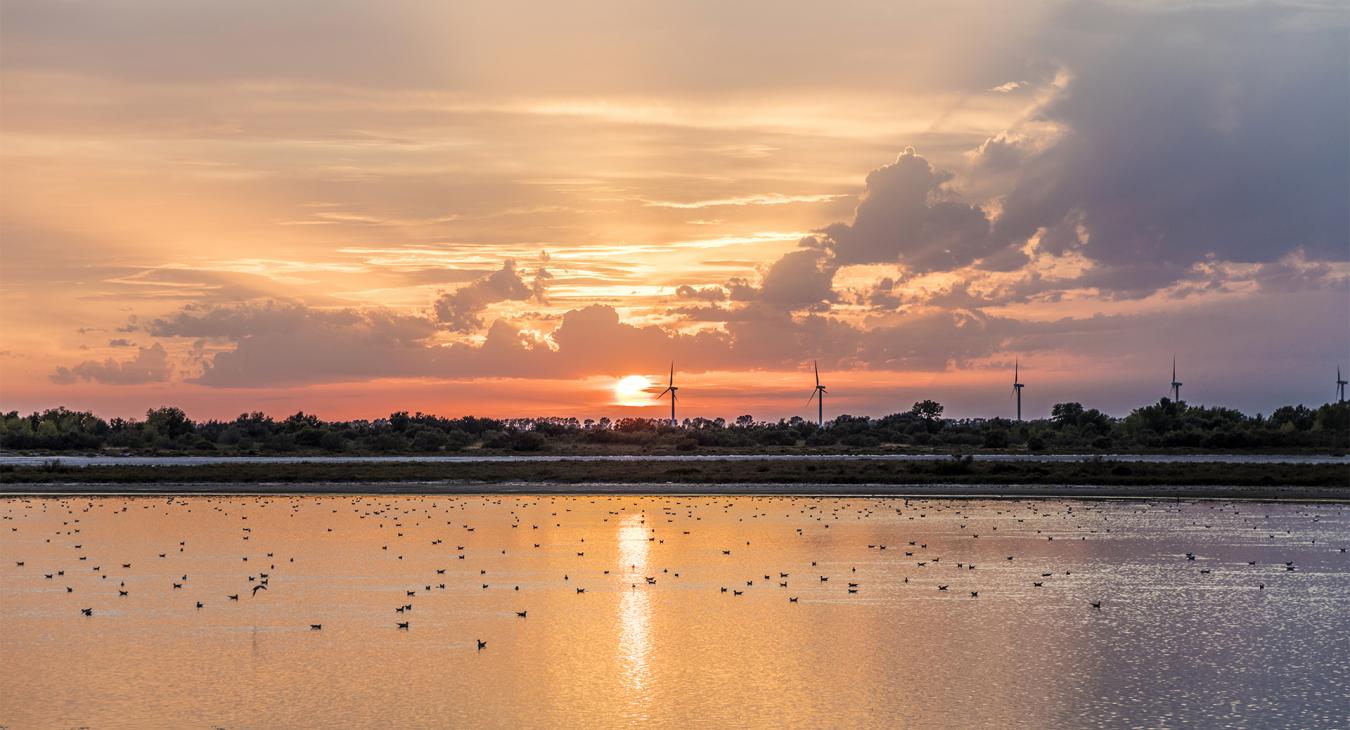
[0,453,1350,467]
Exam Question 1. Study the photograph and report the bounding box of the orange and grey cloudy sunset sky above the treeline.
[0,0,1350,418]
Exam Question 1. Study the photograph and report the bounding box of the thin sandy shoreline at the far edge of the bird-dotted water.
[0,482,1350,502]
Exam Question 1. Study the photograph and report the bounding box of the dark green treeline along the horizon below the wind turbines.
[0,398,1350,453]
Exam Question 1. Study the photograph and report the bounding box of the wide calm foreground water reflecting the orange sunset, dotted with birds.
[0,497,1350,727]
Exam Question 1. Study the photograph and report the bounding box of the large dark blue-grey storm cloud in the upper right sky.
[987,4,1350,296]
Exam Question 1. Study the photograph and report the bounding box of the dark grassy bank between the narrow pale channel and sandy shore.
[0,459,1350,494]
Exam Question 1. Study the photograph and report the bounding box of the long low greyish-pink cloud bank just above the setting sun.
[134,294,1020,387]
